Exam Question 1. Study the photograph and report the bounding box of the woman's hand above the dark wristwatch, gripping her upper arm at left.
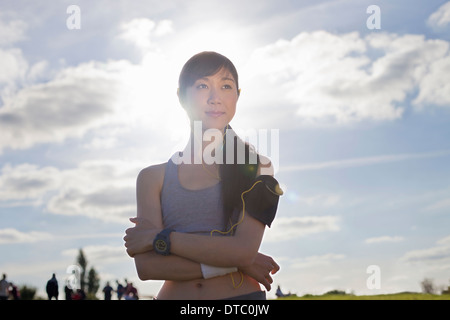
[123,218,161,257]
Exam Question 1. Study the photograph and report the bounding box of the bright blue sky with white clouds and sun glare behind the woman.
[0,0,450,298]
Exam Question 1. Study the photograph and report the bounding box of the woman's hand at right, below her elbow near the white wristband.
[239,252,280,291]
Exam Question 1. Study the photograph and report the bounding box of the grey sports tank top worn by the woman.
[161,153,224,235]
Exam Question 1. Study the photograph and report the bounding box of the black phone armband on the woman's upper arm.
[243,175,283,227]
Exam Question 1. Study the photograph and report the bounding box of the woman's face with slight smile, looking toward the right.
[183,68,239,130]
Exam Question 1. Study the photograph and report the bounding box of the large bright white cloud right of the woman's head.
[241,31,450,127]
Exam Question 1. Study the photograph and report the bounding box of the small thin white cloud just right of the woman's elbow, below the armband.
[264,216,340,243]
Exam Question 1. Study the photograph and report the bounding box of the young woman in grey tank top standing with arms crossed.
[124,52,282,300]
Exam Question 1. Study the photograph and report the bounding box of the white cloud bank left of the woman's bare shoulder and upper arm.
[0,161,141,223]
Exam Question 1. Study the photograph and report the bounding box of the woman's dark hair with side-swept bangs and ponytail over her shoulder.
[178,51,259,225]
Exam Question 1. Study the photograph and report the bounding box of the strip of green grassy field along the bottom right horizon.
[277,292,450,300]
